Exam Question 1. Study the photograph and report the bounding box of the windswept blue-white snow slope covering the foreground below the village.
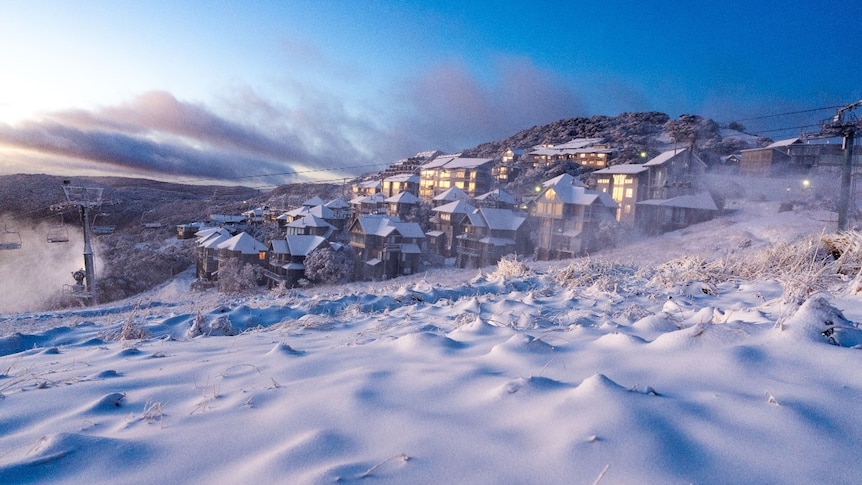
[0,199,862,485]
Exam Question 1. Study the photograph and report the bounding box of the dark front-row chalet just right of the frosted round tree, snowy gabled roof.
[349,214,425,279]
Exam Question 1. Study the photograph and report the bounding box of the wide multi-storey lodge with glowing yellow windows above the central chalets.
[419,155,494,201]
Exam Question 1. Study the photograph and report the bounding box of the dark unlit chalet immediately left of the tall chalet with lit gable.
[455,207,529,268]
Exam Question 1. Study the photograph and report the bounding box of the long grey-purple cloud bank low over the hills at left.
[0,91,384,183]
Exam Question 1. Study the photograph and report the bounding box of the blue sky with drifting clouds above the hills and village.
[0,0,862,184]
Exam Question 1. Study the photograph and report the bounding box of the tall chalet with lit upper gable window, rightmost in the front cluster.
[535,174,618,259]
